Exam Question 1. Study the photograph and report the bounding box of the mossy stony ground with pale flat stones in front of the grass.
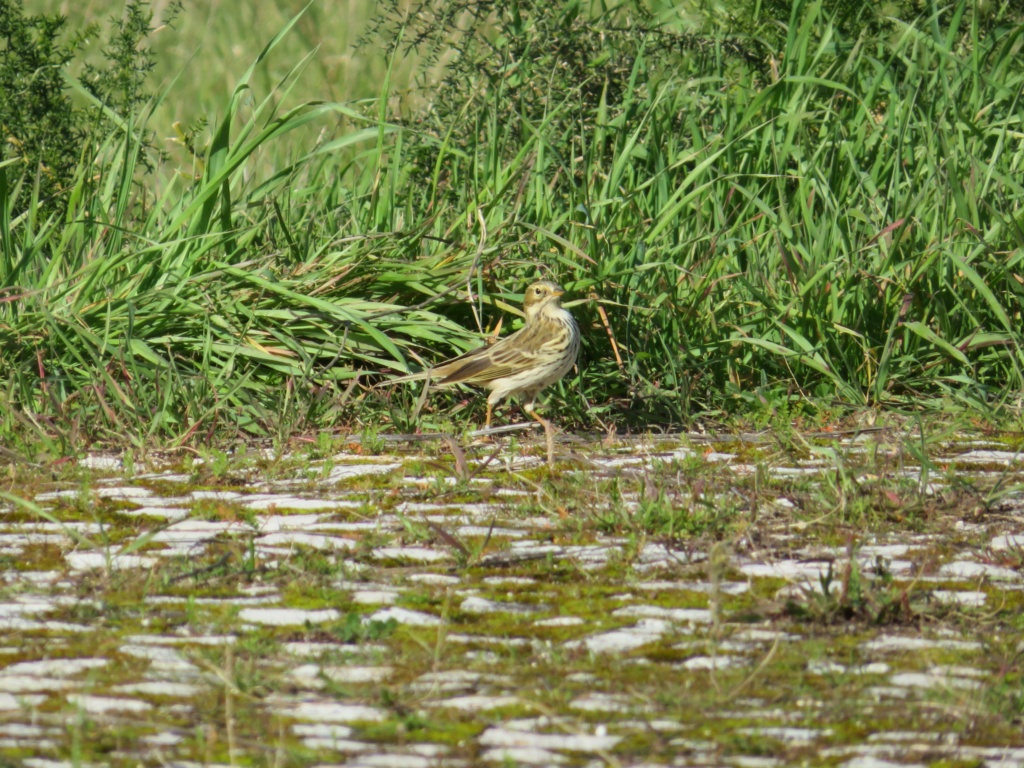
[0,431,1024,768]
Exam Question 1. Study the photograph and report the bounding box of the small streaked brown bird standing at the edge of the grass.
[387,280,580,467]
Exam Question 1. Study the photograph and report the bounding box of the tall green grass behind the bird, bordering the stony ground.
[0,3,1024,454]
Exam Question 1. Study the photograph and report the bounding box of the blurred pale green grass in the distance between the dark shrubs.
[40,0,417,179]
